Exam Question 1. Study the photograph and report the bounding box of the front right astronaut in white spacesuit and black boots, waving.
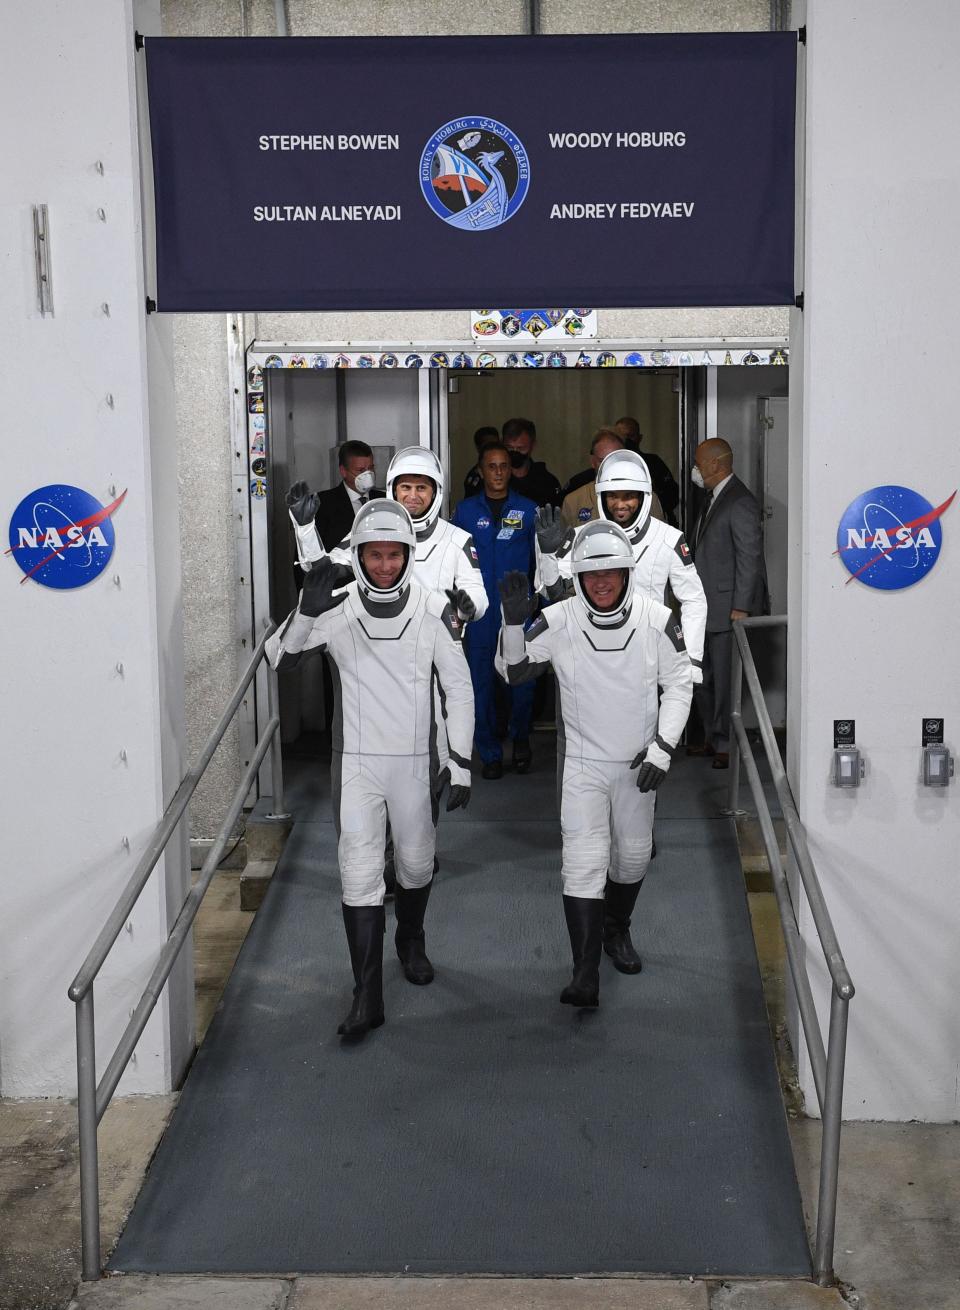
[496,519,693,1006]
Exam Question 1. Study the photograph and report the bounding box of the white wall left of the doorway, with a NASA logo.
[0,0,193,1096]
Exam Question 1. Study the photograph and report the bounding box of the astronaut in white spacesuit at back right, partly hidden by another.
[536,451,707,683]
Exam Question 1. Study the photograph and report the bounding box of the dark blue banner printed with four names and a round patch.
[145,33,796,310]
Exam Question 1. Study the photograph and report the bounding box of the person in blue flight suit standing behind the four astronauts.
[452,441,537,778]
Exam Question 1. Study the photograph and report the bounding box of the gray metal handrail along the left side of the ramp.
[67,624,283,1282]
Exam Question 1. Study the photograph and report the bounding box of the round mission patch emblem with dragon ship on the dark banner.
[420,117,530,232]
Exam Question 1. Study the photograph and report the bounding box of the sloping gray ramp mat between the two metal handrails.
[111,774,809,1277]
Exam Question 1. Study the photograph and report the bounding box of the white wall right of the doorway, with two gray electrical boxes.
[791,0,960,1121]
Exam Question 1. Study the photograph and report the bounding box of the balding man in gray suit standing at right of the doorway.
[688,438,767,769]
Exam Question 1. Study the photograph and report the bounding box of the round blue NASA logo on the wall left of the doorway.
[7,483,127,591]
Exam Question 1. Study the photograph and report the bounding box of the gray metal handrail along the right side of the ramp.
[729,614,854,1286]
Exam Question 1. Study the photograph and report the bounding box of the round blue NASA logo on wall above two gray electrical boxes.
[834,486,956,591]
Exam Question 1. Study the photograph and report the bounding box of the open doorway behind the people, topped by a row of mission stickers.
[238,343,790,770]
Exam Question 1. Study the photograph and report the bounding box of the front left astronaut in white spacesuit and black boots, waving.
[267,499,473,1036]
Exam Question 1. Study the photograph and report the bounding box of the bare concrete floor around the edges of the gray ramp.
[0,848,960,1310]
